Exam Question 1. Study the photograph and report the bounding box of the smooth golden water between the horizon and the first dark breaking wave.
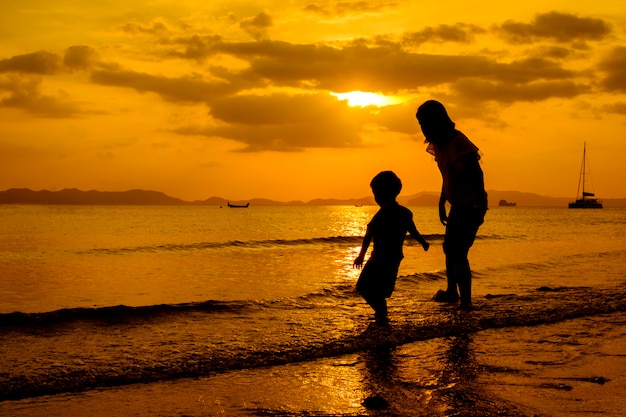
[0,206,626,313]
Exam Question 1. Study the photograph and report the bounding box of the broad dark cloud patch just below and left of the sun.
[177,93,370,152]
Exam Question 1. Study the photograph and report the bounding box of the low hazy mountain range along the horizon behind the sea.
[0,188,626,207]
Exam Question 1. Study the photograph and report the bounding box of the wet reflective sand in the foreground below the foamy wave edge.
[0,312,626,417]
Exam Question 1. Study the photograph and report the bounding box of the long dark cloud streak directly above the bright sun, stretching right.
[230,43,574,93]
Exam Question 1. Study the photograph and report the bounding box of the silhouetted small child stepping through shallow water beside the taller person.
[353,171,430,323]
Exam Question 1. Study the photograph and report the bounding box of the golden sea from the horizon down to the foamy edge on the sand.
[0,205,626,412]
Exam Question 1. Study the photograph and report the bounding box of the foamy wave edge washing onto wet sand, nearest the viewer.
[0,287,626,401]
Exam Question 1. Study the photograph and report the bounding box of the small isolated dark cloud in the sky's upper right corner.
[499,12,611,43]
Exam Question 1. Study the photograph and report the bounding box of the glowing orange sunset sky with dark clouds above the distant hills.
[0,0,626,201]
